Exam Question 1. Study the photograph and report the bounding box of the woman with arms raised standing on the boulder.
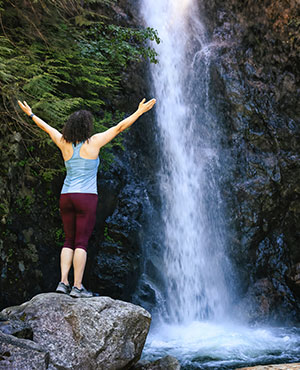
[18,99,156,298]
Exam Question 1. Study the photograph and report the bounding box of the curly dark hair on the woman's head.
[62,109,94,145]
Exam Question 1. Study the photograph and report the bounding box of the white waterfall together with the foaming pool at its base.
[140,0,299,369]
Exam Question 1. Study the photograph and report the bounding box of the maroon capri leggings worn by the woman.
[59,193,98,251]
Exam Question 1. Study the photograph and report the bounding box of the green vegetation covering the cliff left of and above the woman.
[0,0,159,305]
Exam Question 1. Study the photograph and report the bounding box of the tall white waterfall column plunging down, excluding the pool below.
[141,0,230,323]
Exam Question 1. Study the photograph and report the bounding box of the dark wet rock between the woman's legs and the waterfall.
[86,154,150,300]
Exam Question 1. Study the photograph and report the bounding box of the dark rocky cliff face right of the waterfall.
[200,0,300,321]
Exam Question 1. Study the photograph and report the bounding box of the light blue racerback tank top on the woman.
[61,142,100,194]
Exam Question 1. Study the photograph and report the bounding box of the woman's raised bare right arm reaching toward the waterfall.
[93,98,156,149]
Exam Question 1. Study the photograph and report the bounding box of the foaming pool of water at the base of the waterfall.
[142,321,300,370]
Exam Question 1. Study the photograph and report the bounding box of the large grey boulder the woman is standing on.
[0,293,151,370]
